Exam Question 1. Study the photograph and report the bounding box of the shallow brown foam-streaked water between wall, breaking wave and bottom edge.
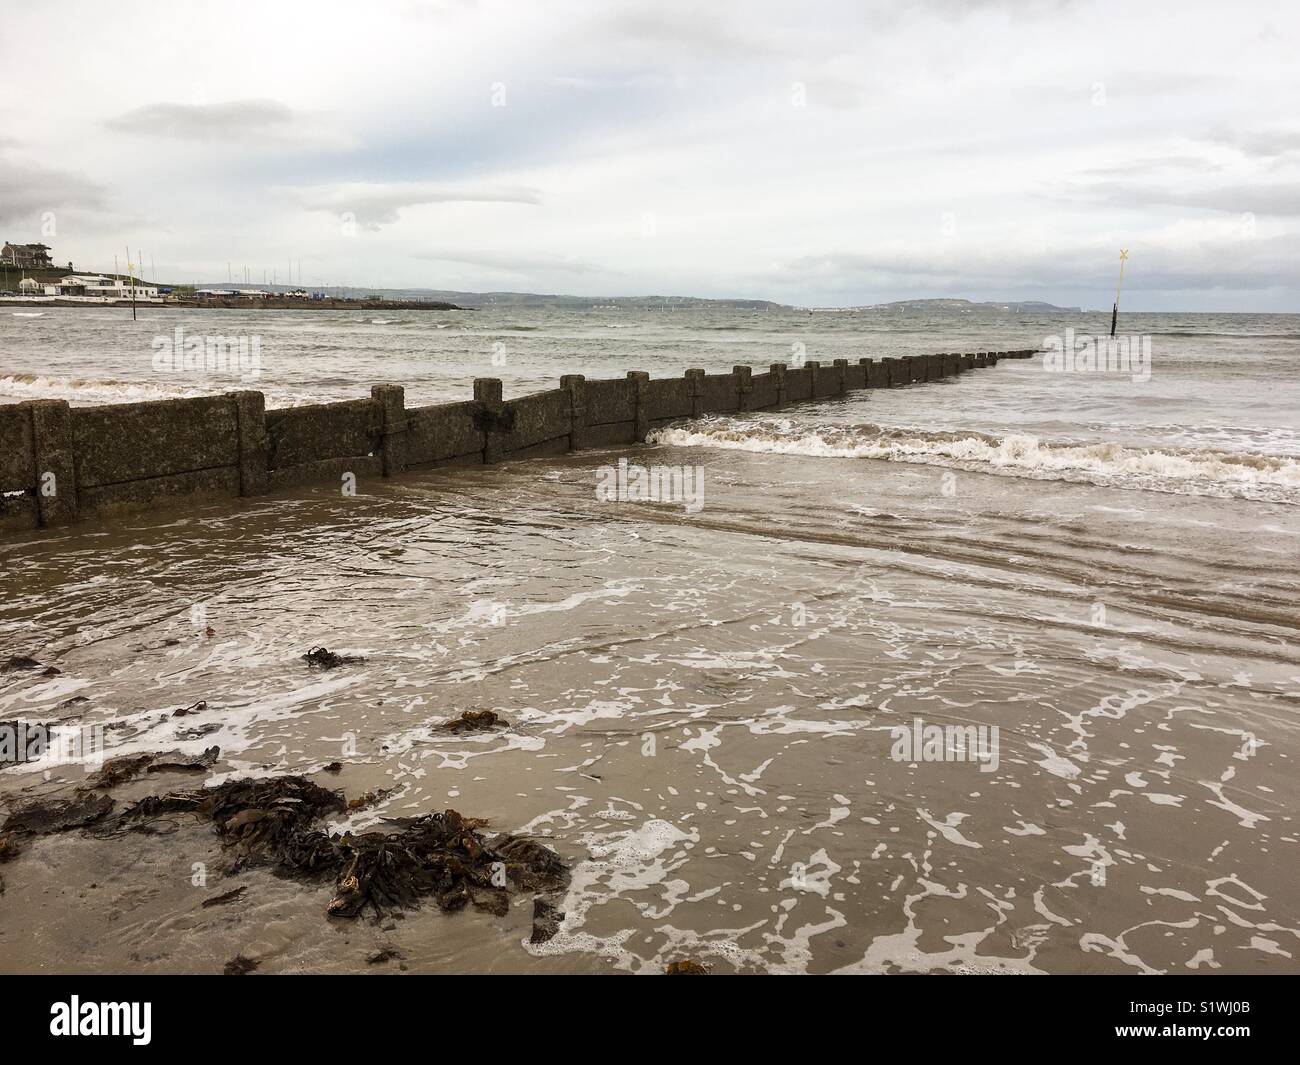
[0,431,1300,973]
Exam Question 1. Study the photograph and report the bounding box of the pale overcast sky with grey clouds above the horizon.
[0,0,1300,312]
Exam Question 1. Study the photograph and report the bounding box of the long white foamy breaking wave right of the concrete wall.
[650,419,1300,505]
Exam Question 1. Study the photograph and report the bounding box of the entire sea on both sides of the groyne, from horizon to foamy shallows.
[0,306,1300,974]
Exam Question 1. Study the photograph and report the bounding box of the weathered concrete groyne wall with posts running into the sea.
[0,351,1034,531]
